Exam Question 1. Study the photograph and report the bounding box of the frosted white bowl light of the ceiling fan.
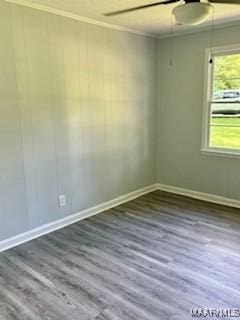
[173,2,212,25]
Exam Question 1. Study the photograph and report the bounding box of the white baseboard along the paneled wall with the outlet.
[0,184,157,252]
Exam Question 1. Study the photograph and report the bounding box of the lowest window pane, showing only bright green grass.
[209,126,240,149]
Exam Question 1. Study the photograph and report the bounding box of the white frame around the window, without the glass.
[201,44,240,159]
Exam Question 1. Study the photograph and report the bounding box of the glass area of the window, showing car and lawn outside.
[205,53,240,151]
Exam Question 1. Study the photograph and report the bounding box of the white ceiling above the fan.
[11,0,240,36]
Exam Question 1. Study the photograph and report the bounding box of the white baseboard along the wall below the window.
[157,183,240,208]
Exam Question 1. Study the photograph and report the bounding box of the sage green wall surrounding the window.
[158,26,240,200]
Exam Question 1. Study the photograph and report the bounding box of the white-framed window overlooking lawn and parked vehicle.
[202,45,240,156]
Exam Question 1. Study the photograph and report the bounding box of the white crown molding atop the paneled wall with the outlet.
[4,0,158,39]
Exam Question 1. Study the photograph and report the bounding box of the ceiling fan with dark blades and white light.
[104,0,240,25]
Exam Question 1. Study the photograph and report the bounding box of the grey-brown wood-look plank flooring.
[0,191,240,320]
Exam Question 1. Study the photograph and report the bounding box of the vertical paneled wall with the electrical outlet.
[0,0,157,240]
